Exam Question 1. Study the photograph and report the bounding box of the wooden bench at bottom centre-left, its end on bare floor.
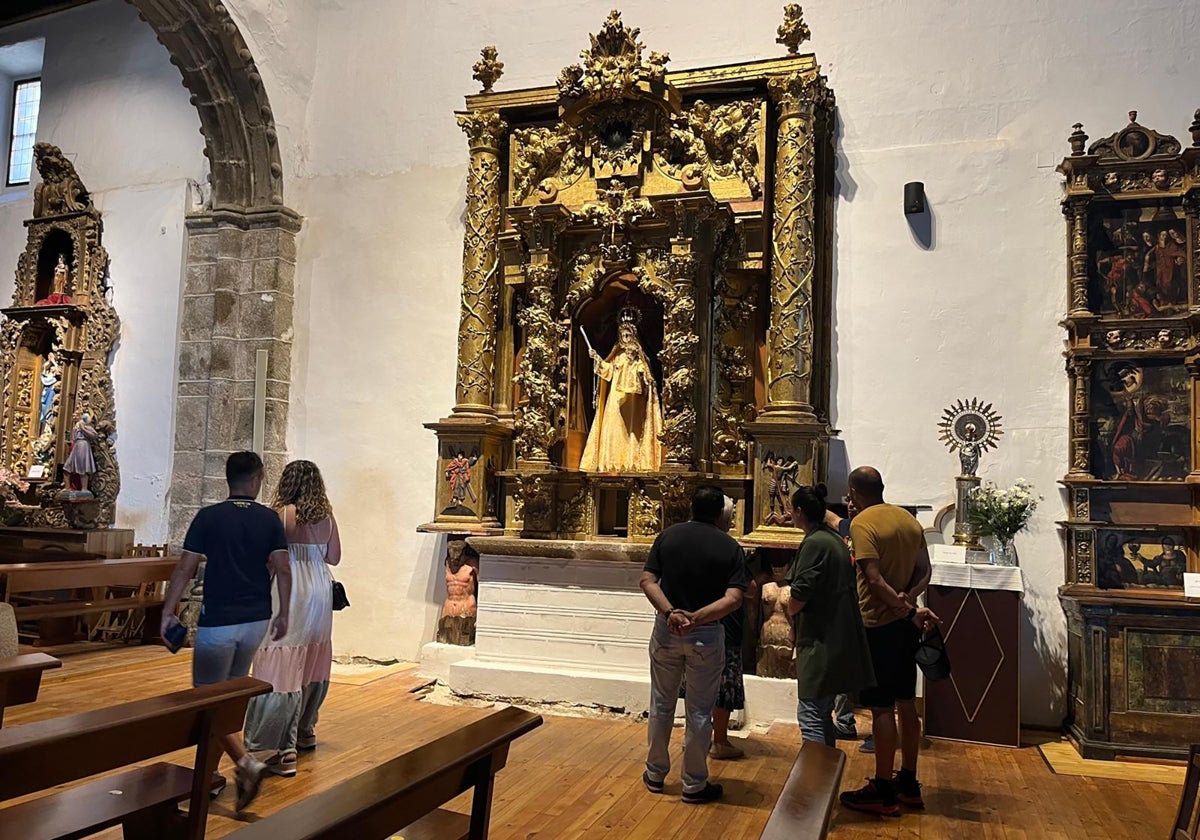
[229,707,541,840]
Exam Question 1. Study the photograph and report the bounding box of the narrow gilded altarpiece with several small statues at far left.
[0,143,120,528]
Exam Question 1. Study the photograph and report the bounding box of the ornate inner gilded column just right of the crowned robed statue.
[660,245,700,469]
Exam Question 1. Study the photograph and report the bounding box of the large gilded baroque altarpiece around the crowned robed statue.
[422,7,834,546]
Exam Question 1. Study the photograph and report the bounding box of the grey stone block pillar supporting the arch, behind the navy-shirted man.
[170,208,300,550]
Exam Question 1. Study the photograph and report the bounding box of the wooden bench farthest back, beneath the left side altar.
[0,557,179,641]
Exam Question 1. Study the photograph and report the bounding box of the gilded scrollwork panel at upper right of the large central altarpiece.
[654,100,762,198]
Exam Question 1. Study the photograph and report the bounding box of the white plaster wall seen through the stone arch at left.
[0,0,205,542]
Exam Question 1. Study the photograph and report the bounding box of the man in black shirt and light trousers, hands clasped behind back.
[641,486,750,804]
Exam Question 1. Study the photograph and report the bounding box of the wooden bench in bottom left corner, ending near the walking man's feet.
[0,677,270,840]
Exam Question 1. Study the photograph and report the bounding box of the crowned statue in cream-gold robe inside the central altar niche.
[580,306,662,473]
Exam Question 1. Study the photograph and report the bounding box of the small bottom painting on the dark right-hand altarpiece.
[1096,528,1188,589]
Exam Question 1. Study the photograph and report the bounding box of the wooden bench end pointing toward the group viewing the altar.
[758,740,846,840]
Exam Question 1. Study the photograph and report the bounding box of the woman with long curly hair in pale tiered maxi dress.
[245,461,342,776]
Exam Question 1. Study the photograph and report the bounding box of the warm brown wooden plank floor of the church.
[0,647,1180,840]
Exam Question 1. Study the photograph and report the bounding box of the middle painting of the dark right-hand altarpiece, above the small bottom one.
[1088,359,1192,481]
